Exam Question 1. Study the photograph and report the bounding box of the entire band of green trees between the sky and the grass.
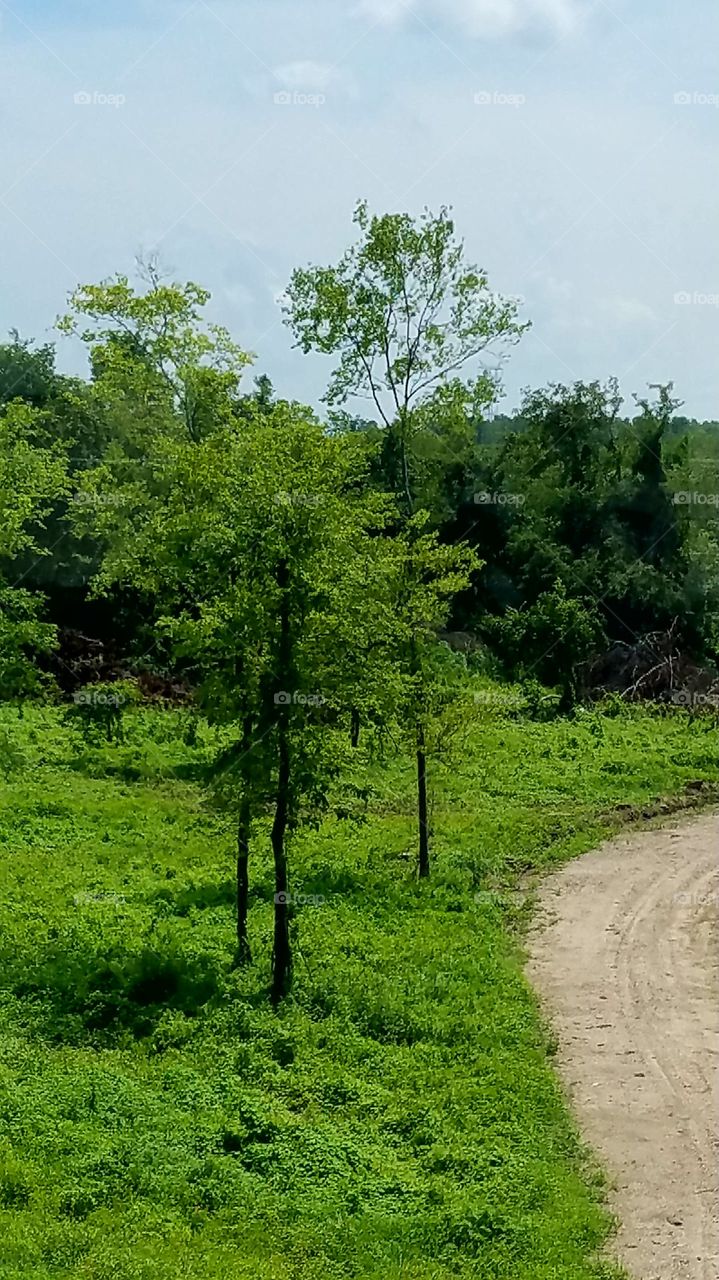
[0,204,719,1000]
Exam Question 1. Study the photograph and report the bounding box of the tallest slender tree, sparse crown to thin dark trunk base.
[285,201,514,876]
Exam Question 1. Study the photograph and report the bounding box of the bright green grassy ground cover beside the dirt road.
[0,708,715,1280]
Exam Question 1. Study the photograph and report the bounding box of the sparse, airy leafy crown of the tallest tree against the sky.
[285,201,526,425]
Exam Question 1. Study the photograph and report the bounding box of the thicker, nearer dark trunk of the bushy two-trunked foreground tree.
[271,559,292,1005]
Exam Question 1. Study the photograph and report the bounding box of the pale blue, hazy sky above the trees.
[0,0,719,419]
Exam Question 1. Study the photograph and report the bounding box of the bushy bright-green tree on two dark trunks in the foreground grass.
[70,404,394,1002]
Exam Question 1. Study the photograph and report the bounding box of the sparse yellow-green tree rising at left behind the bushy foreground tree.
[55,270,255,663]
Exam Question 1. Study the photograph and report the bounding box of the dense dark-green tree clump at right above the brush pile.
[459,380,719,659]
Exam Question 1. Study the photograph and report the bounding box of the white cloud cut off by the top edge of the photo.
[360,0,581,37]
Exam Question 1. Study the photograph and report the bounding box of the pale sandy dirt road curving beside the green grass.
[528,814,719,1280]
